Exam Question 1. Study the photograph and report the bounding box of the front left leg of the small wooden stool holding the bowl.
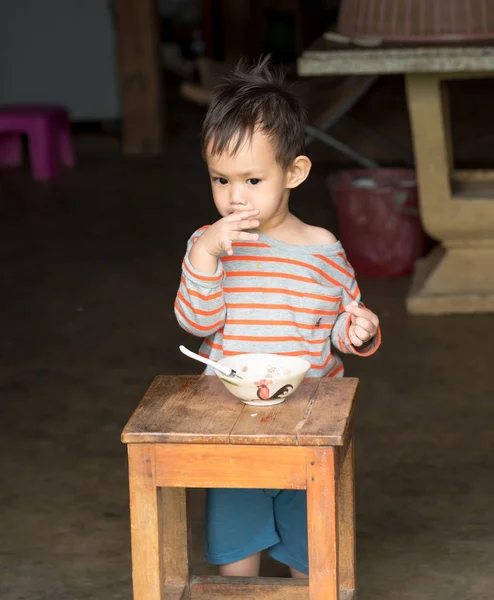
[128,444,165,600]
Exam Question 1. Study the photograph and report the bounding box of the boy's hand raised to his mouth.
[197,210,259,257]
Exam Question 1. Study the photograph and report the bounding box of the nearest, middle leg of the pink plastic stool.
[28,119,60,181]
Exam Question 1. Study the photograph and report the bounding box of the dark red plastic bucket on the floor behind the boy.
[327,169,428,277]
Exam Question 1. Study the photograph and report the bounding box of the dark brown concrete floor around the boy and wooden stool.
[0,91,494,600]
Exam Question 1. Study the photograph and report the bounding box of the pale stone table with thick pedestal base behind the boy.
[298,38,494,314]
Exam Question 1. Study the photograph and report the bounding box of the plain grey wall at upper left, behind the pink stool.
[0,0,119,121]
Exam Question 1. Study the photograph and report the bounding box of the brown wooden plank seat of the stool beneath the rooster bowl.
[122,375,359,446]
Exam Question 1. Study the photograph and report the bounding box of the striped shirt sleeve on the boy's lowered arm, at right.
[331,253,381,356]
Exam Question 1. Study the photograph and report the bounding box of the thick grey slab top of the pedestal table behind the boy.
[297,36,494,77]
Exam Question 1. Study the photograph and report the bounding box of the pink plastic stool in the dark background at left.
[0,105,75,181]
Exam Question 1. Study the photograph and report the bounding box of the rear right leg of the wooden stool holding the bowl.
[338,437,355,590]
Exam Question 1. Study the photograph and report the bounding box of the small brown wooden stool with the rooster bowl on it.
[122,376,358,600]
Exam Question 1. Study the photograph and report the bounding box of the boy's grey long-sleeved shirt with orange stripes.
[175,227,381,377]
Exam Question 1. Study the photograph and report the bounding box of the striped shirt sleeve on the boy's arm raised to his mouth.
[175,228,226,337]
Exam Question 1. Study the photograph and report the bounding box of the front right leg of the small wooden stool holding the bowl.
[307,448,339,600]
